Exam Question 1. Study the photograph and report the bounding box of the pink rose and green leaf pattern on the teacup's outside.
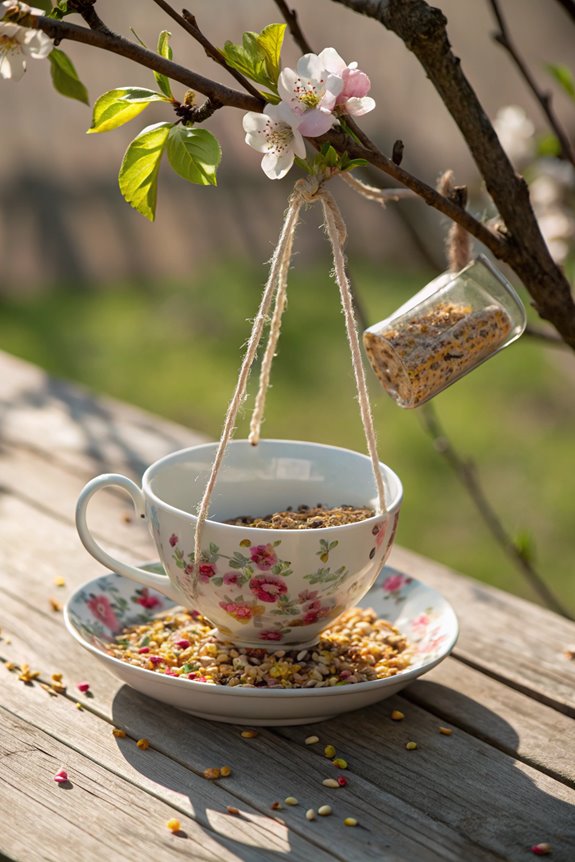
[169,534,360,642]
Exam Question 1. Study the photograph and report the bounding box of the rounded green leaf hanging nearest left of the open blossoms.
[167,125,222,186]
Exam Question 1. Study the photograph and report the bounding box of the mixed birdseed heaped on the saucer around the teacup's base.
[107,608,411,689]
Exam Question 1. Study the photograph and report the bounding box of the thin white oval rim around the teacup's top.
[142,437,403,536]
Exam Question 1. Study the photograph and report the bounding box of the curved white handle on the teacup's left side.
[76,473,182,603]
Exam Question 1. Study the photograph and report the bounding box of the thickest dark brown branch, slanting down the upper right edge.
[332,0,575,350]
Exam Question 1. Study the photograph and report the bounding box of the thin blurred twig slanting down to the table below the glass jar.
[420,403,573,620]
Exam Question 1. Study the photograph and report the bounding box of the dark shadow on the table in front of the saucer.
[113,681,575,862]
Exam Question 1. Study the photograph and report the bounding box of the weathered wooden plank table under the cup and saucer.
[0,354,575,862]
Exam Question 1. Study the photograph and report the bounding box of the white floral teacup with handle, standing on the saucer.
[76,440,402,648]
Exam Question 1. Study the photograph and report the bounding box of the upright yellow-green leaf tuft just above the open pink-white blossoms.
[221,24,285,93]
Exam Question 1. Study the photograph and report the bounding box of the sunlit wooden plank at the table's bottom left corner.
[0,707,284,862]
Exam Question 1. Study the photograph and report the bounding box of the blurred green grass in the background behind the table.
[0,261,575,610]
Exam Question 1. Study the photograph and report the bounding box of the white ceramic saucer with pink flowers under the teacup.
[64,563,458,725]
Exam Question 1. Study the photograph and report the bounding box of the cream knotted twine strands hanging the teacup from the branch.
[194,177,387,584]
